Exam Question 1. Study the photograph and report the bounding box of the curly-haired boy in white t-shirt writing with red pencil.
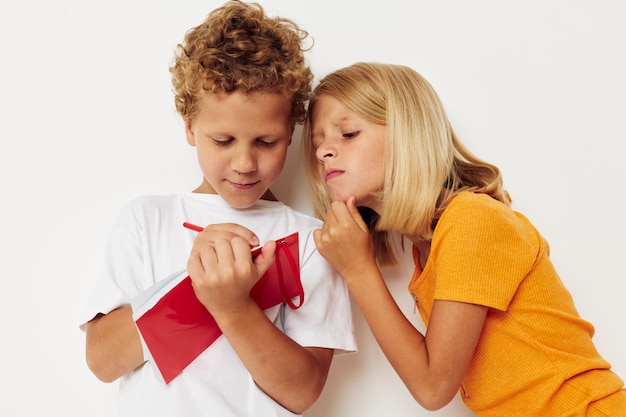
[81,1,355,417]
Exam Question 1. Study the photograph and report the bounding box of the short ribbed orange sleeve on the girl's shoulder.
[431,193,539,311]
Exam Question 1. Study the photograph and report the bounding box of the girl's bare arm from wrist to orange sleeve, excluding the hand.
[348,271,487,411]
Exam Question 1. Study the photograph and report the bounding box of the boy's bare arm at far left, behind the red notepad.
[85,307,144,382]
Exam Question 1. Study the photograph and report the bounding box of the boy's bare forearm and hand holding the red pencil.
[187,234,333,414]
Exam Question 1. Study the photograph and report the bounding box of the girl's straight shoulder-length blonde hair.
[303,62,510,265]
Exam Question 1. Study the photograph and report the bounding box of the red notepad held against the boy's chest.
[133,232,304,384]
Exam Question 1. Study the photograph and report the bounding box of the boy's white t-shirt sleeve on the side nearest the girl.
[283,232,357,353]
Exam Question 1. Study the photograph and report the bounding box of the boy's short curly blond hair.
[170,0,313,123]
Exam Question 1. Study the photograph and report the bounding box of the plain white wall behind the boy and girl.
[0,0,626,417]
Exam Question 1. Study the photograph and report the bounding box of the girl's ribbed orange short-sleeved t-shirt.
[409,192,626,417]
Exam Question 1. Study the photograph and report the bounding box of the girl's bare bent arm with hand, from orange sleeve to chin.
[314,201,487,410]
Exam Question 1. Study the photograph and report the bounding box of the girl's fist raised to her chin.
[313,197,377,283]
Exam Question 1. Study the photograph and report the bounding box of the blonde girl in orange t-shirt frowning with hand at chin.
[304,63,626,417]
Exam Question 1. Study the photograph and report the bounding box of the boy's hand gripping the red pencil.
[187,234,276,323]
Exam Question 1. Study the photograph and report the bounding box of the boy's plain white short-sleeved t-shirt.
[81,193,356,417]
